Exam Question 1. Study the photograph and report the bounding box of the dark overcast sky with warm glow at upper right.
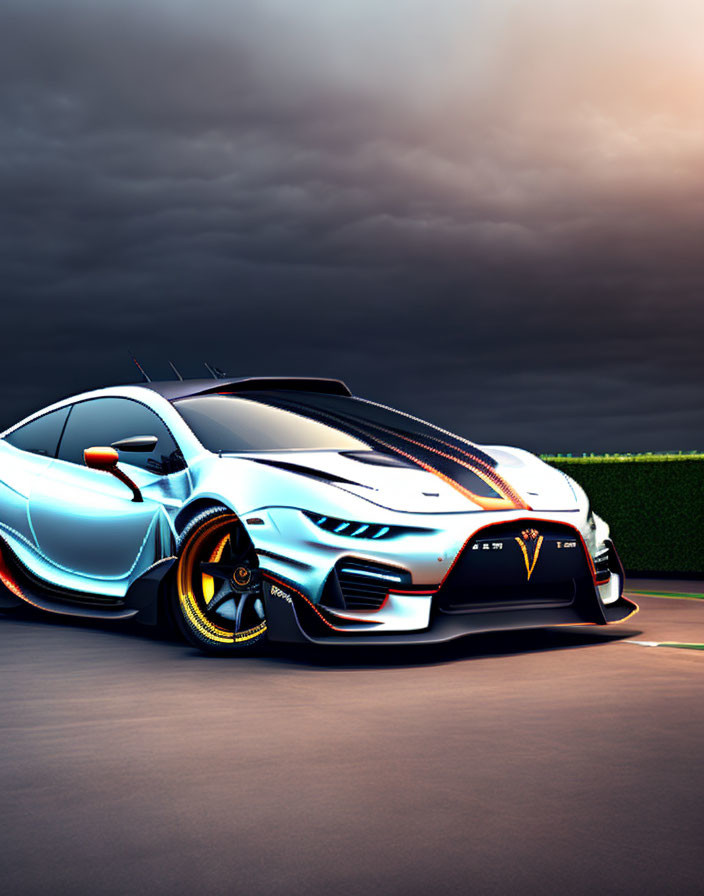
[0,0,704,452]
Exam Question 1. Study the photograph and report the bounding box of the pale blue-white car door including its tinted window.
[29,396,187,591]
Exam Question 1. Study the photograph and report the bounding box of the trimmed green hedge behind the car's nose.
[544,455,704,575]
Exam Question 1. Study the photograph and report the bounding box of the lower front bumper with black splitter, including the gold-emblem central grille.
[265,519,638,645]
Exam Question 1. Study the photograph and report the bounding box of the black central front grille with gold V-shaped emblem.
[436,520,593,613]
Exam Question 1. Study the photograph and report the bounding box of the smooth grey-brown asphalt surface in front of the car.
[0,582,704,896]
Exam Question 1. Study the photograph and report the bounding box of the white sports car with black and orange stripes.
[0,378,637,653]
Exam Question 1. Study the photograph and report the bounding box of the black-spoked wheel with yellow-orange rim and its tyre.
[172,507,266,653]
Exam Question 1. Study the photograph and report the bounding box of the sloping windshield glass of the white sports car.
[173,395,369,454]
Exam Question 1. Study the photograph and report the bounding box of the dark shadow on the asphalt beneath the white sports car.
[0,607,642,669]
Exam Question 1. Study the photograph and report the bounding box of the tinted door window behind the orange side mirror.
[58,398,185,474]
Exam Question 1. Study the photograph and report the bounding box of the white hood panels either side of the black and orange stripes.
[228,447,579,513]
